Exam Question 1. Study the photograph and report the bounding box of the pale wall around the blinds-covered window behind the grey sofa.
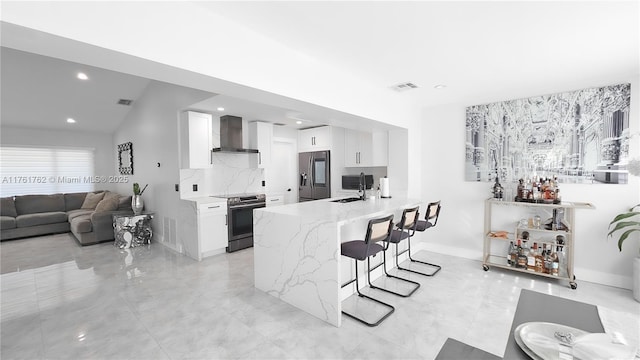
[0,125,118,190]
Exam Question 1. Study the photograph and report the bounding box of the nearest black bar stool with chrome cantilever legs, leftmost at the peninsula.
[340,214,395,326]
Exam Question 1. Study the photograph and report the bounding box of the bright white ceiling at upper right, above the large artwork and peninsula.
[197,1,640,106]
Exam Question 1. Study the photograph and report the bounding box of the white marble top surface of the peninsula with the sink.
[256,196,421,226]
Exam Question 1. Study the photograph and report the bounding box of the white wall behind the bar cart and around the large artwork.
[422,76,640,288]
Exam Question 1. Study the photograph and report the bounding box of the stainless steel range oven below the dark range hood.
[221,194,266,252]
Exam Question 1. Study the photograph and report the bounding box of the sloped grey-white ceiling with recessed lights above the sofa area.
[0,47,149,133]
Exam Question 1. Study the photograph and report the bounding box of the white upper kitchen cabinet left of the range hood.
[180,111,219,169]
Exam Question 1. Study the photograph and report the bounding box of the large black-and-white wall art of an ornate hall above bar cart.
[465,84,631,184]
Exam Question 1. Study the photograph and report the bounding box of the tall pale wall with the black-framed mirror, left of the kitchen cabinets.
[113,81,211,249]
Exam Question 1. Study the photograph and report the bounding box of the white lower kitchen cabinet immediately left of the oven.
[197,202,229,260]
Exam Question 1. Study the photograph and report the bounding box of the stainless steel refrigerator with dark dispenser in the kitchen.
[298,151,331,202]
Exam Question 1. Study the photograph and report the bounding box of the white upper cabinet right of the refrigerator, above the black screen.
[344,129,389,167]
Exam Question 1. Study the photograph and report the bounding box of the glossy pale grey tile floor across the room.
[0,234,640,359]
